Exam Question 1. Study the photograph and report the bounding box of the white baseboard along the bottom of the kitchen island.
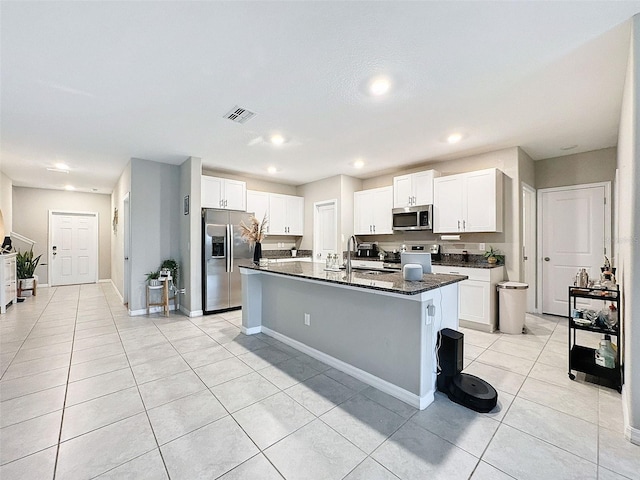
[260,326,435,410]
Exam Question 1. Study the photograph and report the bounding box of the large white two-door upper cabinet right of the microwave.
[433,168,503,233]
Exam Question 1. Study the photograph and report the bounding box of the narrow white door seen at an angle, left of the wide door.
[522,183,537,312]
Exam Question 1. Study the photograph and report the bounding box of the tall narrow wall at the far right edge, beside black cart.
[614,15,640,444]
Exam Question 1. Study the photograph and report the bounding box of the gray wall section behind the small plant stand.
[129,158,182,312]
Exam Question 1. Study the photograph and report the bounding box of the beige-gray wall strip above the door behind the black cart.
[535,147,617,188]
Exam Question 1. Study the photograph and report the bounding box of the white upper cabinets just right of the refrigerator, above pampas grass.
[247,190,304,236]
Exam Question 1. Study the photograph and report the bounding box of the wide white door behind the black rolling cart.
[538,183,611,316]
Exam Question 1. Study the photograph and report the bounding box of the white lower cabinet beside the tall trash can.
[433,265,504,332]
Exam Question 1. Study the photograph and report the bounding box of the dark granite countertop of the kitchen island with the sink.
[239,262,468,295]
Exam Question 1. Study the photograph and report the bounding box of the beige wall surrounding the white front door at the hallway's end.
[13,186,112,284]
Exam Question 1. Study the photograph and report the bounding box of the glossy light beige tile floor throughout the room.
[0,284,640,480]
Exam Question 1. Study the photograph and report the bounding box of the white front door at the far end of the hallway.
[49,211,98,286]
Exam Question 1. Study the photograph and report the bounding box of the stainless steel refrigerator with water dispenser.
[202,208,253,313]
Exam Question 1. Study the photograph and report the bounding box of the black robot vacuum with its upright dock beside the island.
[437,328,498,413]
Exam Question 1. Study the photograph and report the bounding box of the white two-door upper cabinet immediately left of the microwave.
[353,187,393,235]
